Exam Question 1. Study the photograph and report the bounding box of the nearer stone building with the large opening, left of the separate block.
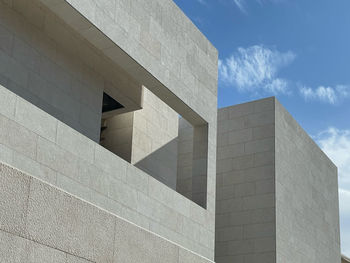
[0,0,217,262]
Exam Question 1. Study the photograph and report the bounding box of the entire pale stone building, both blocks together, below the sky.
[0,0,340,263]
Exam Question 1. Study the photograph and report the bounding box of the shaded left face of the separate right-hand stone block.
[215,98,276,263]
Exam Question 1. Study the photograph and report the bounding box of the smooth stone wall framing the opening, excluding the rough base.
[0,0,217,259]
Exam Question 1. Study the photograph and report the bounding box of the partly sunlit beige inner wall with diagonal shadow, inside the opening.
[101,88,179,190]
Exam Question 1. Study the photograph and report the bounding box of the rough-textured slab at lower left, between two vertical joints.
[26,178,115,262]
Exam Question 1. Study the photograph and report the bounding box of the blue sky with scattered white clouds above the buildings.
[175,0,350,257]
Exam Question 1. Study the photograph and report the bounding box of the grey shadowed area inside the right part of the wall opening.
[134,118,207,207]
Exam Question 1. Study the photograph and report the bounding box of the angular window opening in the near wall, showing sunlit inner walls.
[100,88,208,208]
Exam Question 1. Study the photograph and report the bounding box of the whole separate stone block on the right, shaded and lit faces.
[215,98,340,263]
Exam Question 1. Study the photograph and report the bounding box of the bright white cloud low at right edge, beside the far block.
[316,128,350,256]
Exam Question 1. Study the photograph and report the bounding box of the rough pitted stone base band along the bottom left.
[0,163,212,263]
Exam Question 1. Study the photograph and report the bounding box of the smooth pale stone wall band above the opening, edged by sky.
[40,0,218,124]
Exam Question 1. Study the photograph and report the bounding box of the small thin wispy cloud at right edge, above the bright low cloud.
[299,85,350,104]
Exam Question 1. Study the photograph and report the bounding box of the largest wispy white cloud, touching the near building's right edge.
[219,45,295,94]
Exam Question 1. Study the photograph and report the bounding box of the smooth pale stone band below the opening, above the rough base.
[0,86,214,258]
